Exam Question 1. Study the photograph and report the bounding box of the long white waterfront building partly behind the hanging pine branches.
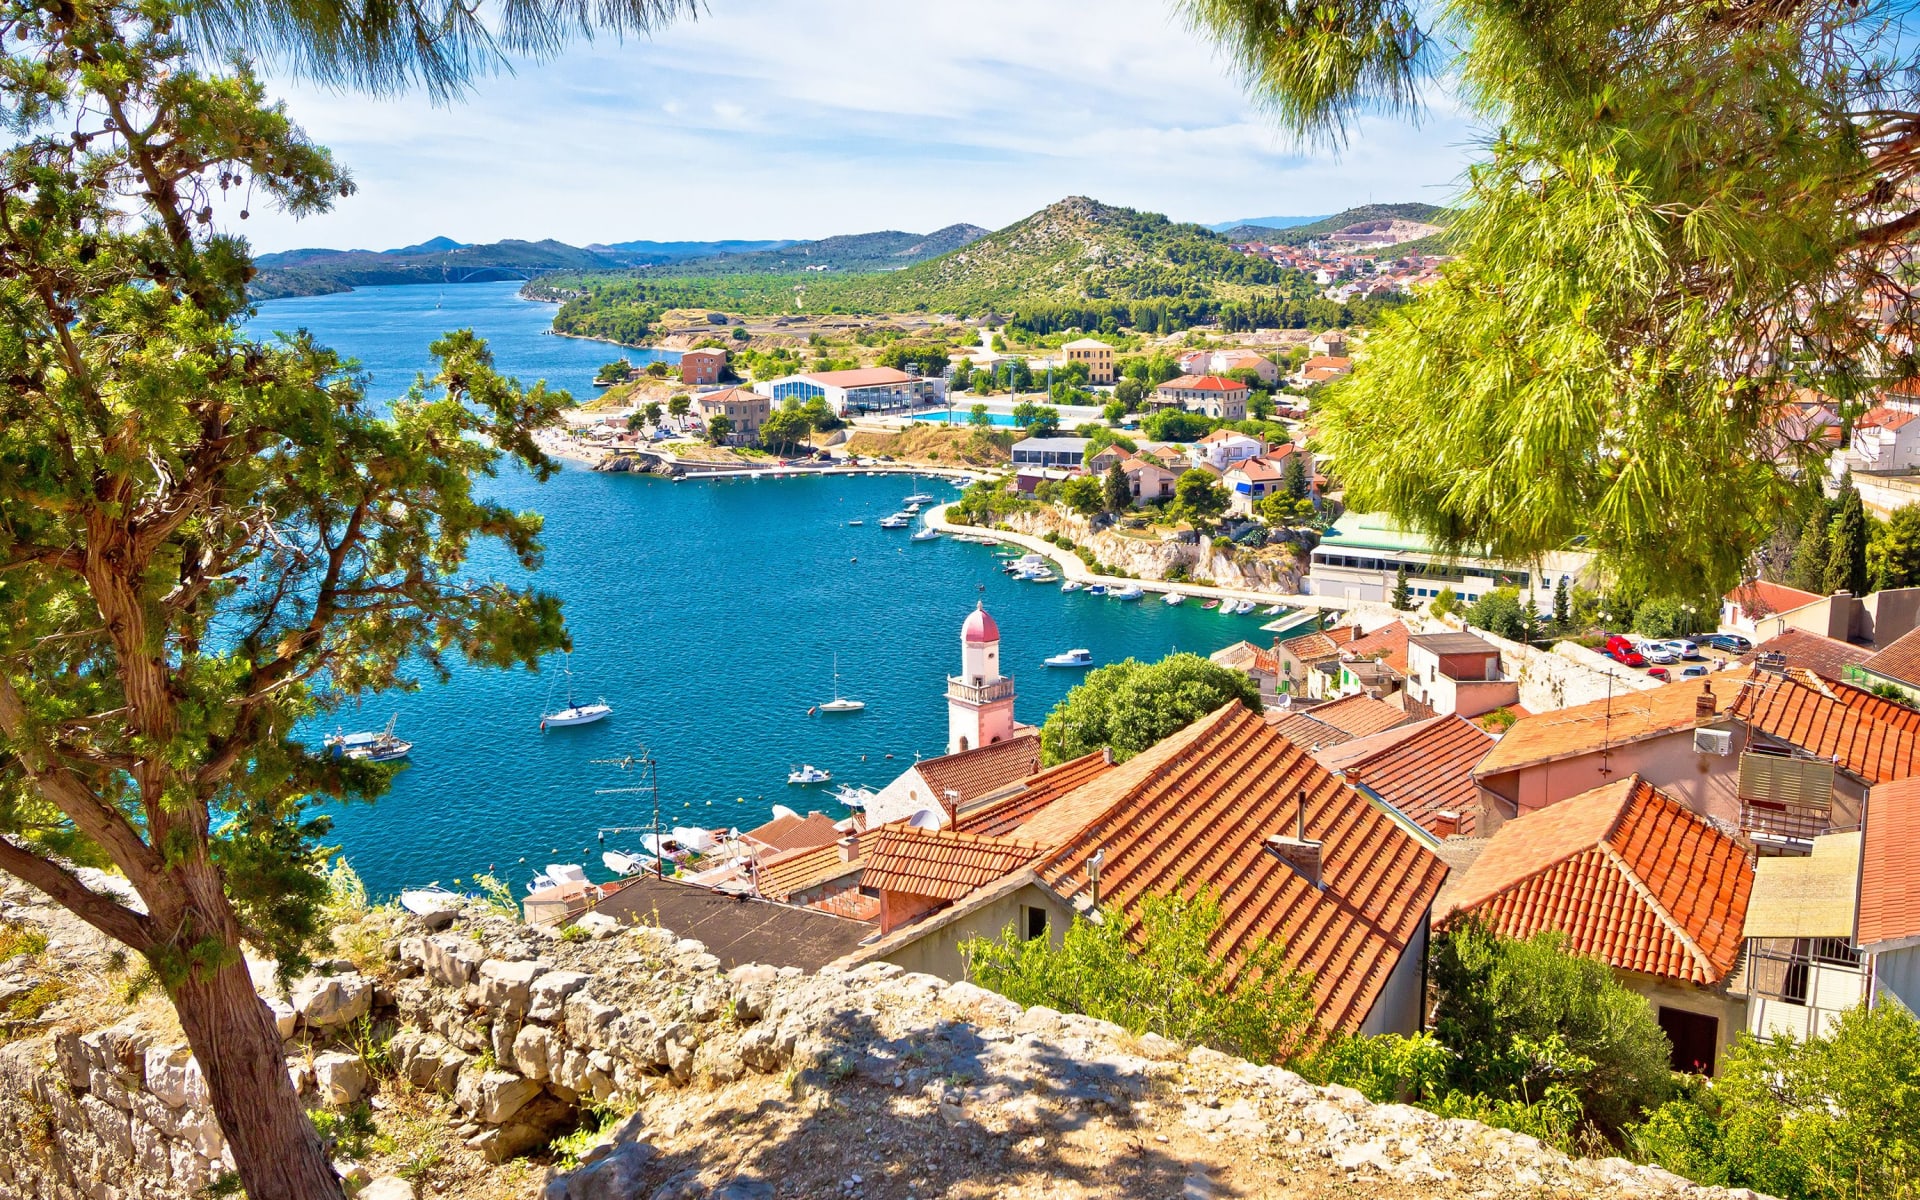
[1308,513,1592,612]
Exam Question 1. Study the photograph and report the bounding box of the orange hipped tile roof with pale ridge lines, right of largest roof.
[1442,776,1753,987]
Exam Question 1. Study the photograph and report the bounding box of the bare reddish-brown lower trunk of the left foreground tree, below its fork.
[173,962,342,1200]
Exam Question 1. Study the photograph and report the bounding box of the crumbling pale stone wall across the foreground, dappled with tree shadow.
[0,894,1774,1200]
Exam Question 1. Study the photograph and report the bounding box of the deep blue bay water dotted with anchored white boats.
[255,284,1263,893]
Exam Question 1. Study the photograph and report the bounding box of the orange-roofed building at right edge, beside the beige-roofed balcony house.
[1853,778,1920,1014]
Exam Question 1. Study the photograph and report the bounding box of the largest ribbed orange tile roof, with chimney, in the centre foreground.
[1020,701,1446,1031]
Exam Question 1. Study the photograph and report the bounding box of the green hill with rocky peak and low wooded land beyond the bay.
[528,196,1344,342]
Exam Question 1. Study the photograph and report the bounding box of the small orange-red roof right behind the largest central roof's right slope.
[1317,714,1494,837]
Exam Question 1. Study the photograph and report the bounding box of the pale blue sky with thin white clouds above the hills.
[244,0,1475,252]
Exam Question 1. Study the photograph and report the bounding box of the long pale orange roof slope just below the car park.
[1473,668,1751,780]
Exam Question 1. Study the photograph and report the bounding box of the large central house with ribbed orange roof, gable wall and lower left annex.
[852,703,1446,1035]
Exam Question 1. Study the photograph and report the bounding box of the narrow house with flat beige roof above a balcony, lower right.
[1736,831,1866,1041]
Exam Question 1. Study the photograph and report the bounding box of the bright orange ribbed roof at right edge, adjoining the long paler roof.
[1734,672,1920,783]
